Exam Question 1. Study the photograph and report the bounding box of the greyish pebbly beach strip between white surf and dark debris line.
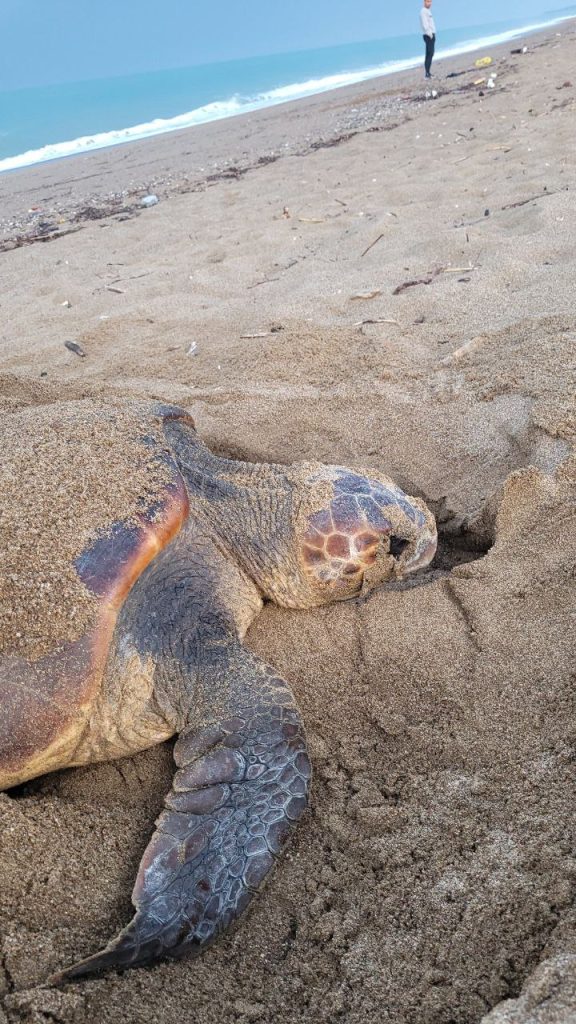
[0,17,576,247]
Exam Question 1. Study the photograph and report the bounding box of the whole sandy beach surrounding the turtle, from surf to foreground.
[0,22,576,1024]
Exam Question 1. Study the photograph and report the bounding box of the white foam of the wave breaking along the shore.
[0,15,572,172]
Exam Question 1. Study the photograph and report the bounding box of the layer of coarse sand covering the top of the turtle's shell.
[0,395,166,659]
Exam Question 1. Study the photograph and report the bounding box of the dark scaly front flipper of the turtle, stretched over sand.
[50,644,311,984]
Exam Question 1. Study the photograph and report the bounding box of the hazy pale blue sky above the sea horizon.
[0,0,562,89]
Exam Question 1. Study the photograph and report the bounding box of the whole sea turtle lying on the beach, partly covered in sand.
[0,398,437,982]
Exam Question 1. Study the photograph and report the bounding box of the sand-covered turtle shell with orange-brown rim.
[0,399,194,788]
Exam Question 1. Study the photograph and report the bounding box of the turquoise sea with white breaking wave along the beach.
[0,6,576,172]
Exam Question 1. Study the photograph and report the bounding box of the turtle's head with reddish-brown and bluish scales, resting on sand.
[268,464,438,607]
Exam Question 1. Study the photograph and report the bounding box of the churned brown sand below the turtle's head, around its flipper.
[2,462,576,1024]
